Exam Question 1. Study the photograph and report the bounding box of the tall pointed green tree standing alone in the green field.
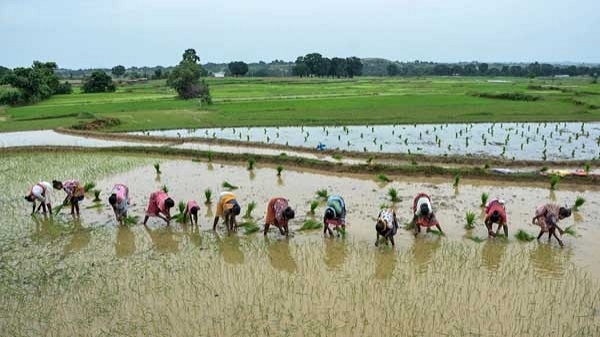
[167,49,212,104]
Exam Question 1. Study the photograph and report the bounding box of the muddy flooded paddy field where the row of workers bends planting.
[0,153,600,336]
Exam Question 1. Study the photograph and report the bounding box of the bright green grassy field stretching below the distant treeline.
[0,77,600,131]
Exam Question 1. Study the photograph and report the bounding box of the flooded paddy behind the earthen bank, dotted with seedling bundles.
[132,123,600,161]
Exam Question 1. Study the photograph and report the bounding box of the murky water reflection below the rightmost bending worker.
[529,240,573,279]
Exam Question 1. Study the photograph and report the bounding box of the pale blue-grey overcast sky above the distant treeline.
[0,0,600,69]
